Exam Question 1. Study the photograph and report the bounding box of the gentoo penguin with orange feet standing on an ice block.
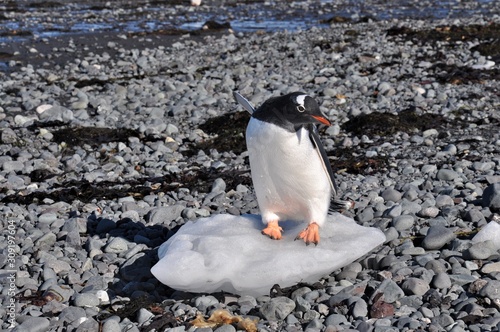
[234,92,343,244]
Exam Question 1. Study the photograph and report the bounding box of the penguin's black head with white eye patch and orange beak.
[252,92,331,132]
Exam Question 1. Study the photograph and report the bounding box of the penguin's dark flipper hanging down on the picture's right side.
[307,124,354,211]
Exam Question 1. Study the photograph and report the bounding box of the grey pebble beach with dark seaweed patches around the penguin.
[0,2,500,332]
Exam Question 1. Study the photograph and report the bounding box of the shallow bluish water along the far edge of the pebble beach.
[0,0,500,43]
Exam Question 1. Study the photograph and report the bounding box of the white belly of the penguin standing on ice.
[246,118,331,226]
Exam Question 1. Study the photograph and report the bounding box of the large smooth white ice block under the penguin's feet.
[151,213,385,296]
